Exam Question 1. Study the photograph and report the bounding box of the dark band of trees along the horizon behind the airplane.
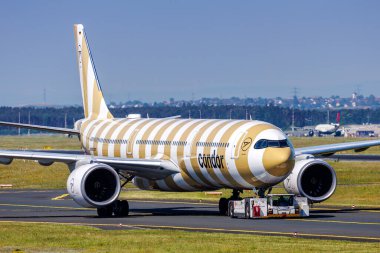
[0,105,380,135]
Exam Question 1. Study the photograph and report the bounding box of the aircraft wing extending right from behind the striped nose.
[295,140,380,156]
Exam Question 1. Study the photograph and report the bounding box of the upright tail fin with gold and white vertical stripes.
[74,24,113,119]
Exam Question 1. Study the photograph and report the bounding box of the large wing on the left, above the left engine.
[0,150,179,179]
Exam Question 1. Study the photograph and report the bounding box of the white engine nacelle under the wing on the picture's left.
[67,163,120,207]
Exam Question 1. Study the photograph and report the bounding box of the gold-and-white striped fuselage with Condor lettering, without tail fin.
[78,118,294,191]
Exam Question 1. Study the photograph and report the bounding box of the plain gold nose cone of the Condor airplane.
[263,147,295,177]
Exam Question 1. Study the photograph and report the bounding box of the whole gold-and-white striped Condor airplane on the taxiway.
[0,24,380,217]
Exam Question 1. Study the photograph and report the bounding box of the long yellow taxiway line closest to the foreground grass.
[0,220,380,241]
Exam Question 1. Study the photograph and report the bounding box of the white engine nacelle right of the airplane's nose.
[284,158,337,202]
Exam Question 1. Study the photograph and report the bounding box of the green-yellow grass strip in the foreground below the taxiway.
[0,222,380,253]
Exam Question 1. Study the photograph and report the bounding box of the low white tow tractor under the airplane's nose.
[228,194,309,219]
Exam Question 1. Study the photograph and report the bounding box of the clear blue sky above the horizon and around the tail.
[0,0,380,106]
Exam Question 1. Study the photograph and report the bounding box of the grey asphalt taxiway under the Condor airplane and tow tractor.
[0,190,380,243]
